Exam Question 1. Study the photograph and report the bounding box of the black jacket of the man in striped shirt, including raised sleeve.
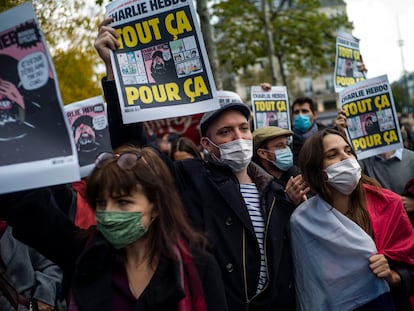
[103,81,295,311]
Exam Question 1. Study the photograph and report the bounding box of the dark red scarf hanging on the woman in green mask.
[174,240,207,311]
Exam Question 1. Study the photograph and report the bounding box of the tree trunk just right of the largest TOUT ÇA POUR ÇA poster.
[197,0,223,90]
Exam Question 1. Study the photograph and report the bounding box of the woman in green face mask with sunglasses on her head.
[0,146,227,311]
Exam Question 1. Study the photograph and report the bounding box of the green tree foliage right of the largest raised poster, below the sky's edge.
[213,0,352,81]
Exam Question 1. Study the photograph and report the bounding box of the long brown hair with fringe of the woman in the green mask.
[86,146,207,261]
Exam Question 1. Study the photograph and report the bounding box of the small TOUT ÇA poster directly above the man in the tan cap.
[251,86,290,130]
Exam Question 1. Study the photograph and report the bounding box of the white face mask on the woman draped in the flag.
[325,158,361,195]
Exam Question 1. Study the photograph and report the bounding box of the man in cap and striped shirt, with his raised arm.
[95,19,295,311]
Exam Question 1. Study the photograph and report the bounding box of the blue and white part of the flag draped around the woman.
[290,195,389,310]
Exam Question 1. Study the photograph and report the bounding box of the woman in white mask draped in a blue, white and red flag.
[290,129,414,311]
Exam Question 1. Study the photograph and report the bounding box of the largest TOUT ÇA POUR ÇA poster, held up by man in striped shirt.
[106,0,219,124]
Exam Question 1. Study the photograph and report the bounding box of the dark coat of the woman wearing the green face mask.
[0,189,227,311]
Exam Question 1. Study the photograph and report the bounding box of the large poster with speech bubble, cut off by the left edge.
[0,2,80,193]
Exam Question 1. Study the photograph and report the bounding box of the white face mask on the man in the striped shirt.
[210,139,253,172]
